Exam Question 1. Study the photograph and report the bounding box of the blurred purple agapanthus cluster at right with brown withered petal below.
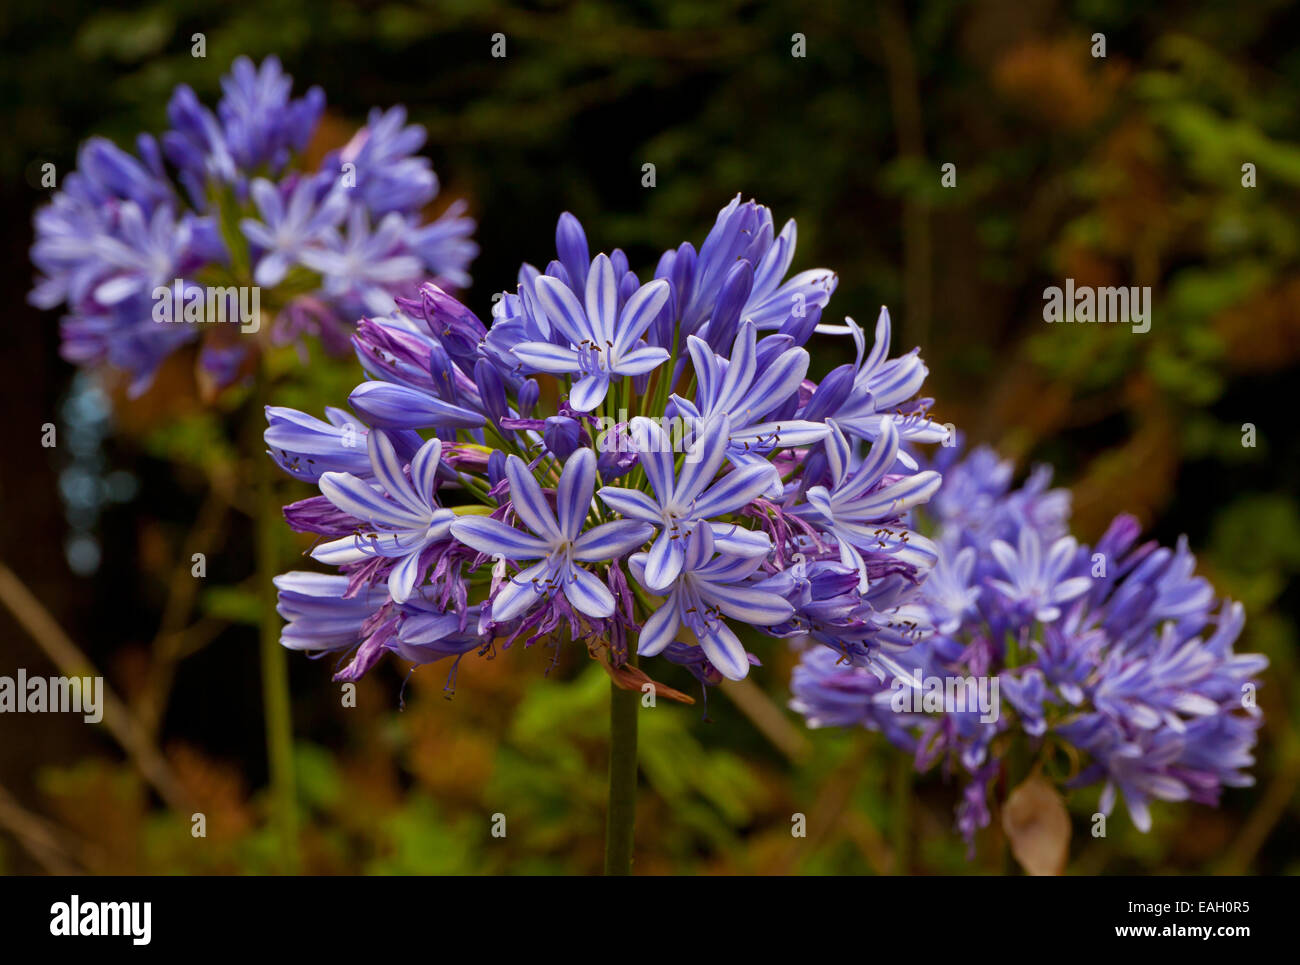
[792,447,1268,840]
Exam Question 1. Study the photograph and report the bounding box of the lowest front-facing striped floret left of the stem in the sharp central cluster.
[451,449,654,623]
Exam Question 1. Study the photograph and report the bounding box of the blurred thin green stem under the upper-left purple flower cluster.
[251,369,298,874]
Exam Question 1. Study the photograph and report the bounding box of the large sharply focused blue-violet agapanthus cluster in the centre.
[265,198,945,697]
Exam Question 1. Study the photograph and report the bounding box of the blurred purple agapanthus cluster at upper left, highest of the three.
[30,57,477,393]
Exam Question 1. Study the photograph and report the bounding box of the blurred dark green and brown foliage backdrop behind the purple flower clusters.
[0,0,1300,874]
